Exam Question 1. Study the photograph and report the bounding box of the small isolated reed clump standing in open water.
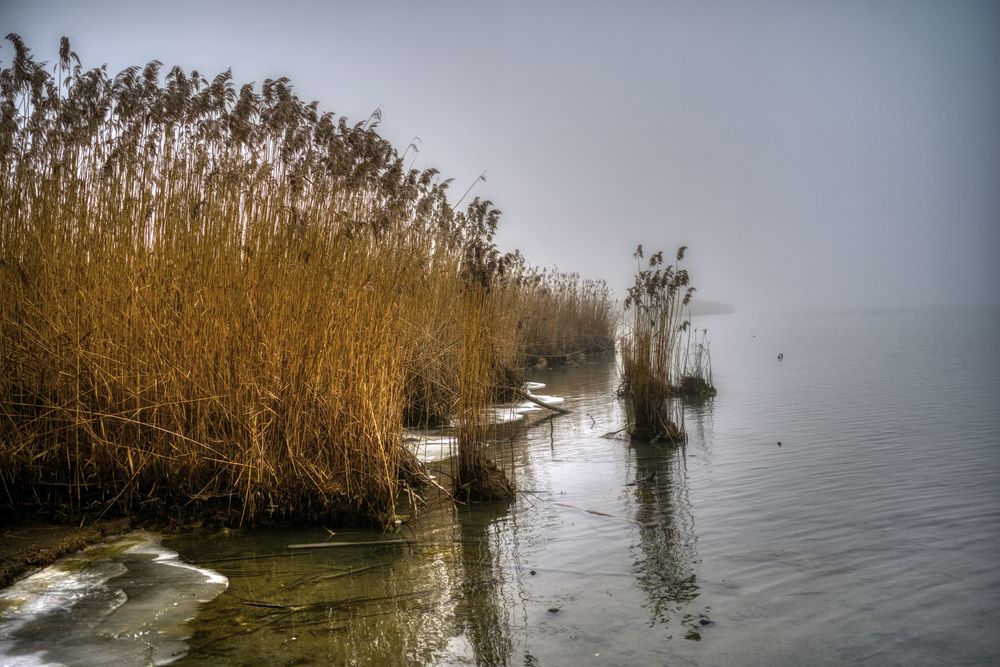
[619,245,715,442]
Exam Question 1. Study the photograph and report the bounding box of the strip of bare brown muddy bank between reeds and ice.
[0,519,132,588]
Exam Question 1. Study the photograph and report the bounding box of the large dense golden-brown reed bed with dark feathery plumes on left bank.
[0,35,610,522]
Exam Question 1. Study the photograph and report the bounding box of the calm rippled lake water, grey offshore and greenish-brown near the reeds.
[0,310,1000,665]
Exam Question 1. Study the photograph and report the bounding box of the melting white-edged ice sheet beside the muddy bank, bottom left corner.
[0,531,227,666]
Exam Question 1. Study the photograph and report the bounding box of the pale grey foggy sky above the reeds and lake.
[0,0,1000,312]
